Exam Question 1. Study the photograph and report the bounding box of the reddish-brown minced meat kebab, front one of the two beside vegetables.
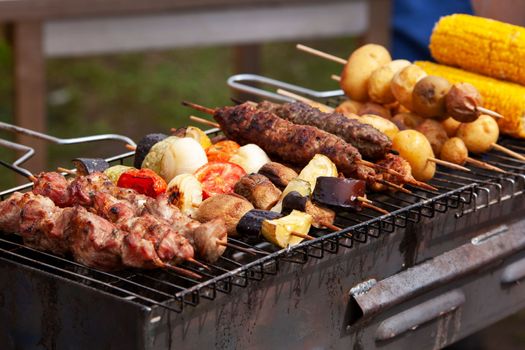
[213,103,373,178]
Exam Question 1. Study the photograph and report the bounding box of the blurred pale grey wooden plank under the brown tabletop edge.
[44,0,368,57]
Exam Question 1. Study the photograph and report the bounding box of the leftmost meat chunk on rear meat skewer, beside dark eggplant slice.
[33,172,70,208]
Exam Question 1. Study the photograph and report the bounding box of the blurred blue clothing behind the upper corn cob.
[392,0,473,61]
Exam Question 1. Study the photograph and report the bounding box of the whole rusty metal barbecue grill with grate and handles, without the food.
[0,75,525,349]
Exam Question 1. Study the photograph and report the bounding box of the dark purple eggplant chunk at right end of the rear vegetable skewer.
[312,176,366,210]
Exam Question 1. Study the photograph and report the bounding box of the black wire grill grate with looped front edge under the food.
[0,121,525,312]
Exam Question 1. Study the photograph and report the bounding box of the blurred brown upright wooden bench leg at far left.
[12,22,47,172]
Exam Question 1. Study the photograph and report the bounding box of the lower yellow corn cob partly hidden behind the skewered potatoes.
[416,61,525,138]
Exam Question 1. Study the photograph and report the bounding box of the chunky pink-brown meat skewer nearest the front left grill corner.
[0,192,200,277]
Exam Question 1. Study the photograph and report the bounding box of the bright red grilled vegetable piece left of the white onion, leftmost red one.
[117,169,167,198]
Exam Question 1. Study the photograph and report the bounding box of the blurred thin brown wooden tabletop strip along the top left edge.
[0,0,348,21]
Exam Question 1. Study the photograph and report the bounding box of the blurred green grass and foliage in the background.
[0,38,355,189]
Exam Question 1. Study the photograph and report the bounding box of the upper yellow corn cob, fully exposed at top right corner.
[430,14,525,85]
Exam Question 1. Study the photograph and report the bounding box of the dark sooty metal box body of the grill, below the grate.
[0,180,525,349]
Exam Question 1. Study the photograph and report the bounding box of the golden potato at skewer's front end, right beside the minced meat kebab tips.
[392,130,436,181]
